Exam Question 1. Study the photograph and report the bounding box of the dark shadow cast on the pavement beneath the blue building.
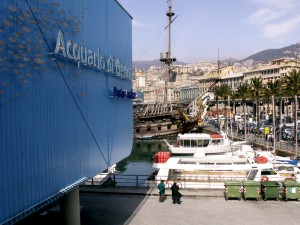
[16,187,154,225]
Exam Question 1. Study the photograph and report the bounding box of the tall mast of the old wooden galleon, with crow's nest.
[160,0,176,103]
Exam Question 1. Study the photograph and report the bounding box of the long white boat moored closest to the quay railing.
[153,145,290,188]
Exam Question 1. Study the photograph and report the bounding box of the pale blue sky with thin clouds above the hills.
[118,0,300,63]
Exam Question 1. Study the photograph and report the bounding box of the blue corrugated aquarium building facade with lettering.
[0,0,134,224]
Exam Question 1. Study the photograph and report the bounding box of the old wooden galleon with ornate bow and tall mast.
[134,0,209,139]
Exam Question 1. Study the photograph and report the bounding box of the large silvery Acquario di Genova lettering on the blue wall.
[55,30,134,80]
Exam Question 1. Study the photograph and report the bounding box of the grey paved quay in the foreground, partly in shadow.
[19,186,300,225]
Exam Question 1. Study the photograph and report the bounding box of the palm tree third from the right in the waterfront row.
[250,77,264,124]
